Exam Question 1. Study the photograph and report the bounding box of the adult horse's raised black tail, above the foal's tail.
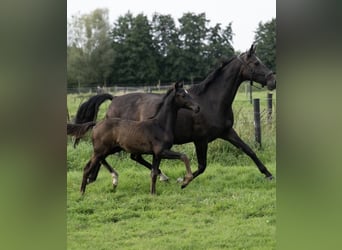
[75,93,113,124]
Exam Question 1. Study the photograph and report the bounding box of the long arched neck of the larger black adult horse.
[202,64,242,109]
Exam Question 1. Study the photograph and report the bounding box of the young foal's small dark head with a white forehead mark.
[173,82,200,113]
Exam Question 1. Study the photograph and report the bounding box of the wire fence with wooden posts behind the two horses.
[67,85,276,146]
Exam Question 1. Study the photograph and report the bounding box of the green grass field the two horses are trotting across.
[67,89,276,249]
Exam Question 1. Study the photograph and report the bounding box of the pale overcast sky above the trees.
[67,0,276,51]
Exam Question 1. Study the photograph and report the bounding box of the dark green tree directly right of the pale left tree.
[111,12,158,84]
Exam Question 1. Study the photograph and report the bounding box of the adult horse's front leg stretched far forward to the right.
[221,128,273,180]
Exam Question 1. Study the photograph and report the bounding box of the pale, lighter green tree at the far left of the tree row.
[67,9,114,86]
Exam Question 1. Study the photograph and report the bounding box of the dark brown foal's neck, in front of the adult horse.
[155,96,178,133]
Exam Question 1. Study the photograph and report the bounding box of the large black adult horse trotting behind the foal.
[71,45,276,182]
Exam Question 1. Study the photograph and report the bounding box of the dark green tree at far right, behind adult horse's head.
[254,18,276,71]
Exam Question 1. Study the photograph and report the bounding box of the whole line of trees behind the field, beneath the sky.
[67,9,276,88]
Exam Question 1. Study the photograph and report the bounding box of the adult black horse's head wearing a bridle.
[237,44,276,90]
